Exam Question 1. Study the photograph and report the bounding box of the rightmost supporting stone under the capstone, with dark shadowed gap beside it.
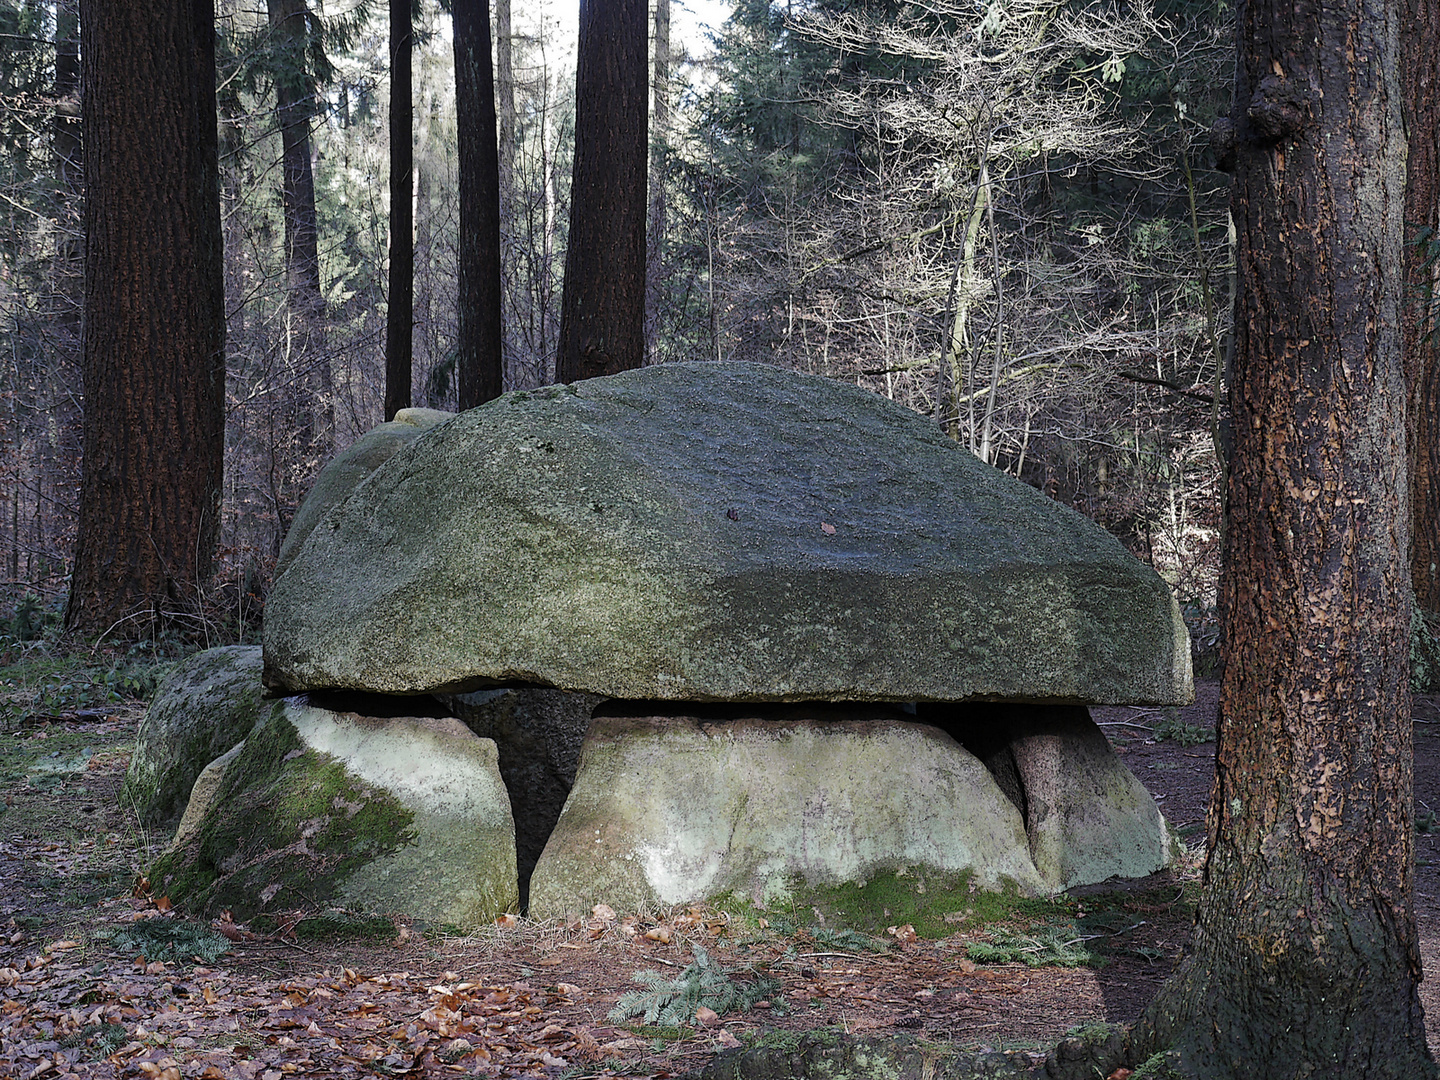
[919,704,1179,891]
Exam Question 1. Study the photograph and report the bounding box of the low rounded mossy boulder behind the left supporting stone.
[120,645,264,835]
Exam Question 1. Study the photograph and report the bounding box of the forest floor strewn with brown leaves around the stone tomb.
[0,672,1440,1080]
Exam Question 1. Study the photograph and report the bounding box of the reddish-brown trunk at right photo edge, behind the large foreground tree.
[1400,0,1440,616]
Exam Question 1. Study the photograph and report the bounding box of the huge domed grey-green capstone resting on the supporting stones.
[265,363,1191,703]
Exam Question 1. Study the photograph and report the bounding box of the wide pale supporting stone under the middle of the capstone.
[530,707,1045,919]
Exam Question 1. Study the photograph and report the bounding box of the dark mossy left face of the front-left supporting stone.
[150,704,415,922]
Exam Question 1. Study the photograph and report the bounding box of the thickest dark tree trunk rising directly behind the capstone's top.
[556,0,649,383]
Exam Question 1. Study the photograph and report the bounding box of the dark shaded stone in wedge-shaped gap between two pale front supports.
[442,690,603,909]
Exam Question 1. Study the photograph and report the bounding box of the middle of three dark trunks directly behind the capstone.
[455,0,504,409]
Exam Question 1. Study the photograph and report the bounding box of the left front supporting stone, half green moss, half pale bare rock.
[148,698,518,926]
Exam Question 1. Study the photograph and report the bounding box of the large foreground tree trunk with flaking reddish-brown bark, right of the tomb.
[1142,0,1434,1080]
